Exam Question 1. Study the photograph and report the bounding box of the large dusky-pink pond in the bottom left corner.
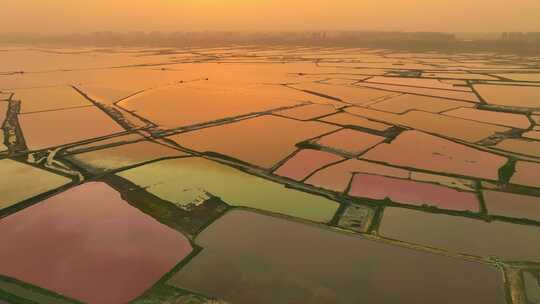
[0,183,192,304]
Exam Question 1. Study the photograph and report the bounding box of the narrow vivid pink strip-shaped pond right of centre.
[349,174,479,211]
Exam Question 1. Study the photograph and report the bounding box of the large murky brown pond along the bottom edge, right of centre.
[168,211,506,304]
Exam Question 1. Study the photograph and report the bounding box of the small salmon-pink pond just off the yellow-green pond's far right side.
[274,149,343,181]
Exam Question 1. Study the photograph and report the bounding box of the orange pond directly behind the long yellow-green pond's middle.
[169,115,339,168]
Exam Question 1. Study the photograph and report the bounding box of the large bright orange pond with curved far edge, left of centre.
[119,82,310,128]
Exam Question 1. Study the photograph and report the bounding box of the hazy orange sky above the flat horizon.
[4,0,540,33]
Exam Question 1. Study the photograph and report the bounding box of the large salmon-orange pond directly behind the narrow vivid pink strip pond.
[362,131,507,180]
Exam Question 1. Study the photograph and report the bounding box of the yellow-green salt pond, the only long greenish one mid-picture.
[118,158,339,222]
